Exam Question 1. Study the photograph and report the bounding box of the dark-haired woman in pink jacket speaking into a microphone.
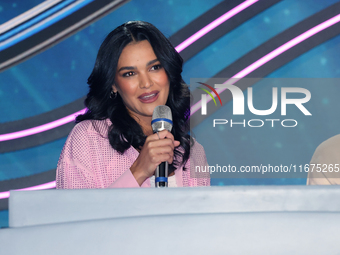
[56,21,210,189]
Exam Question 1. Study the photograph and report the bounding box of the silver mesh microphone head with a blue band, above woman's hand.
[151,105,172,133]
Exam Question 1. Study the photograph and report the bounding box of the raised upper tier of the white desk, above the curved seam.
[9,186,340,228]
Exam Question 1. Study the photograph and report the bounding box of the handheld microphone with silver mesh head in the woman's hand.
[151,105,172,188]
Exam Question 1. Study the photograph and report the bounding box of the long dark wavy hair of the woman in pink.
[76,21,191,172]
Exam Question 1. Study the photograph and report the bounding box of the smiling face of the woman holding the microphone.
[112,40,170,121]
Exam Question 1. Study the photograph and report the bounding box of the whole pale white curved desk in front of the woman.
[0,186,340,255]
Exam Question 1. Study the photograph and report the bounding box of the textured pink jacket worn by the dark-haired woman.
[56,119,210,189]
